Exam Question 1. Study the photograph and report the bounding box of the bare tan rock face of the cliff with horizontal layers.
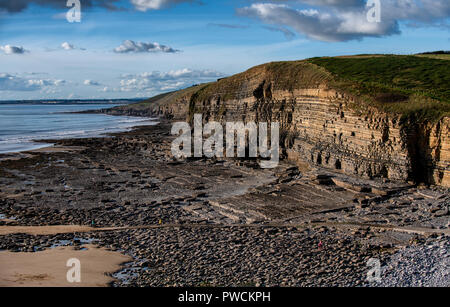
[198,88,450,186]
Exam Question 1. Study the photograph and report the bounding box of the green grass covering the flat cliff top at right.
[308,54,450,121]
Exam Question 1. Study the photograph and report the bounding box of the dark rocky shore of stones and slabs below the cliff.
[0,121,450,286]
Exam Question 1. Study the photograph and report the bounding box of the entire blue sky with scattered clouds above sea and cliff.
[0,0,450,100]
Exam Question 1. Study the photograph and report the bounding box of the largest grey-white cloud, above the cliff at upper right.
[237,0,450,42]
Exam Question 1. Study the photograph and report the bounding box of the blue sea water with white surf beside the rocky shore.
[0,103,156,153]
